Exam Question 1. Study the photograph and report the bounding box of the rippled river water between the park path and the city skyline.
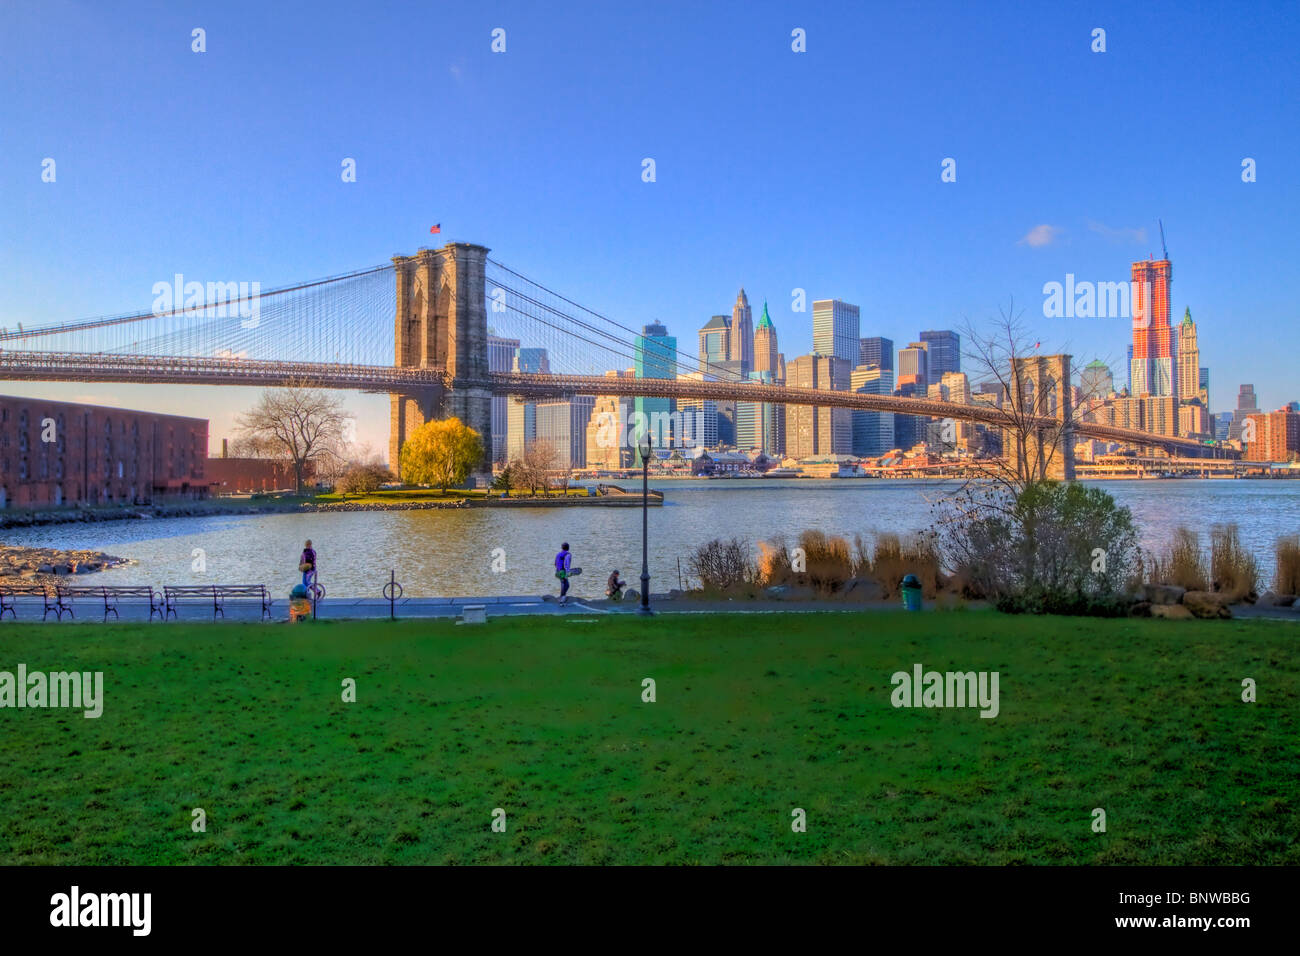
[0,479,1300,597]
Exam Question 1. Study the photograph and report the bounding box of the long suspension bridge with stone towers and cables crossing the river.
[0,243,1206,473]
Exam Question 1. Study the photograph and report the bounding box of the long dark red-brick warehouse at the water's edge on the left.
[0,395,208,507]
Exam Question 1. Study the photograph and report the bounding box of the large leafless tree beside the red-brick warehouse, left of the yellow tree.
[235,385,352,493]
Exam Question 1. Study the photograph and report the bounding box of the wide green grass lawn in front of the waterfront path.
[0,611,1300,864]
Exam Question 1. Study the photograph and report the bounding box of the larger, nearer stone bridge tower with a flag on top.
[389,242,491,472]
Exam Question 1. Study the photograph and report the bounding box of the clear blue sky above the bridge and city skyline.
[0,0,1300,449]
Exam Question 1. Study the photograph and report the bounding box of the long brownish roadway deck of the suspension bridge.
[0,350,1206,455]
